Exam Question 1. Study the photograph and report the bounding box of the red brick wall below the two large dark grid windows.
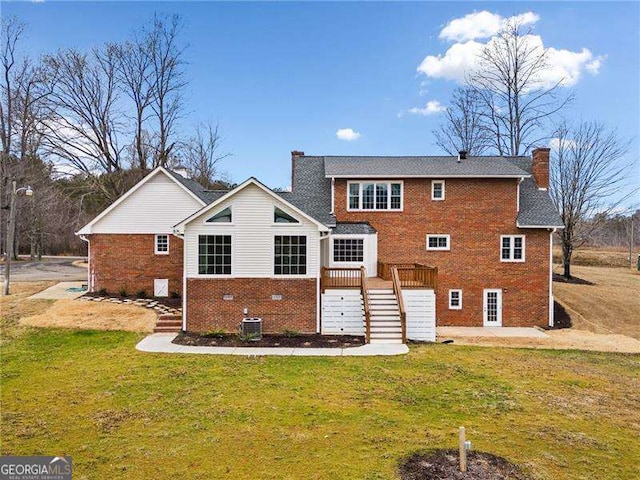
[187,278,317,333]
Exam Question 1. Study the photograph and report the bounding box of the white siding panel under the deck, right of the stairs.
[402,289,436,342]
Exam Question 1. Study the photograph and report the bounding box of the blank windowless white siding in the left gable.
[91,172,202,234]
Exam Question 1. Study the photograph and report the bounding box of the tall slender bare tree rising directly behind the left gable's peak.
[142,15,186,167]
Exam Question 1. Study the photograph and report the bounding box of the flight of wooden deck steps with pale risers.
[366,288,402,343]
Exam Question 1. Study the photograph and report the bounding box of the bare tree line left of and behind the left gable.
[0,15,228,257]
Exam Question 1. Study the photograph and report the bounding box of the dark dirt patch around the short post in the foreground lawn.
[400,450,531,480]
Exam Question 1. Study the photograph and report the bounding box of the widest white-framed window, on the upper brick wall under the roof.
[347,182,403,211]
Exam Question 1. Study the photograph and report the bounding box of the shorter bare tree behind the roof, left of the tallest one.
[432,87,490,156]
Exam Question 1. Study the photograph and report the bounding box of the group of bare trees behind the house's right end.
[432,19,638,278]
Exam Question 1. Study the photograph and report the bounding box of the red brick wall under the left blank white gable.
[89,234,182,296]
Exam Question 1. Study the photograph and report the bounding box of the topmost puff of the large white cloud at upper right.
[439,10,540,42]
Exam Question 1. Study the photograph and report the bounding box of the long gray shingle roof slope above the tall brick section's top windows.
[324,156,529,178]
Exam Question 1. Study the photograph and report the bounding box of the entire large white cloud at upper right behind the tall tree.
[417,11,606,87]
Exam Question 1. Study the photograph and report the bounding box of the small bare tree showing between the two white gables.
[181,123,231,189]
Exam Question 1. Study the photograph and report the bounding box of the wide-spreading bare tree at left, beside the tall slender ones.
[45,47,123,175]
